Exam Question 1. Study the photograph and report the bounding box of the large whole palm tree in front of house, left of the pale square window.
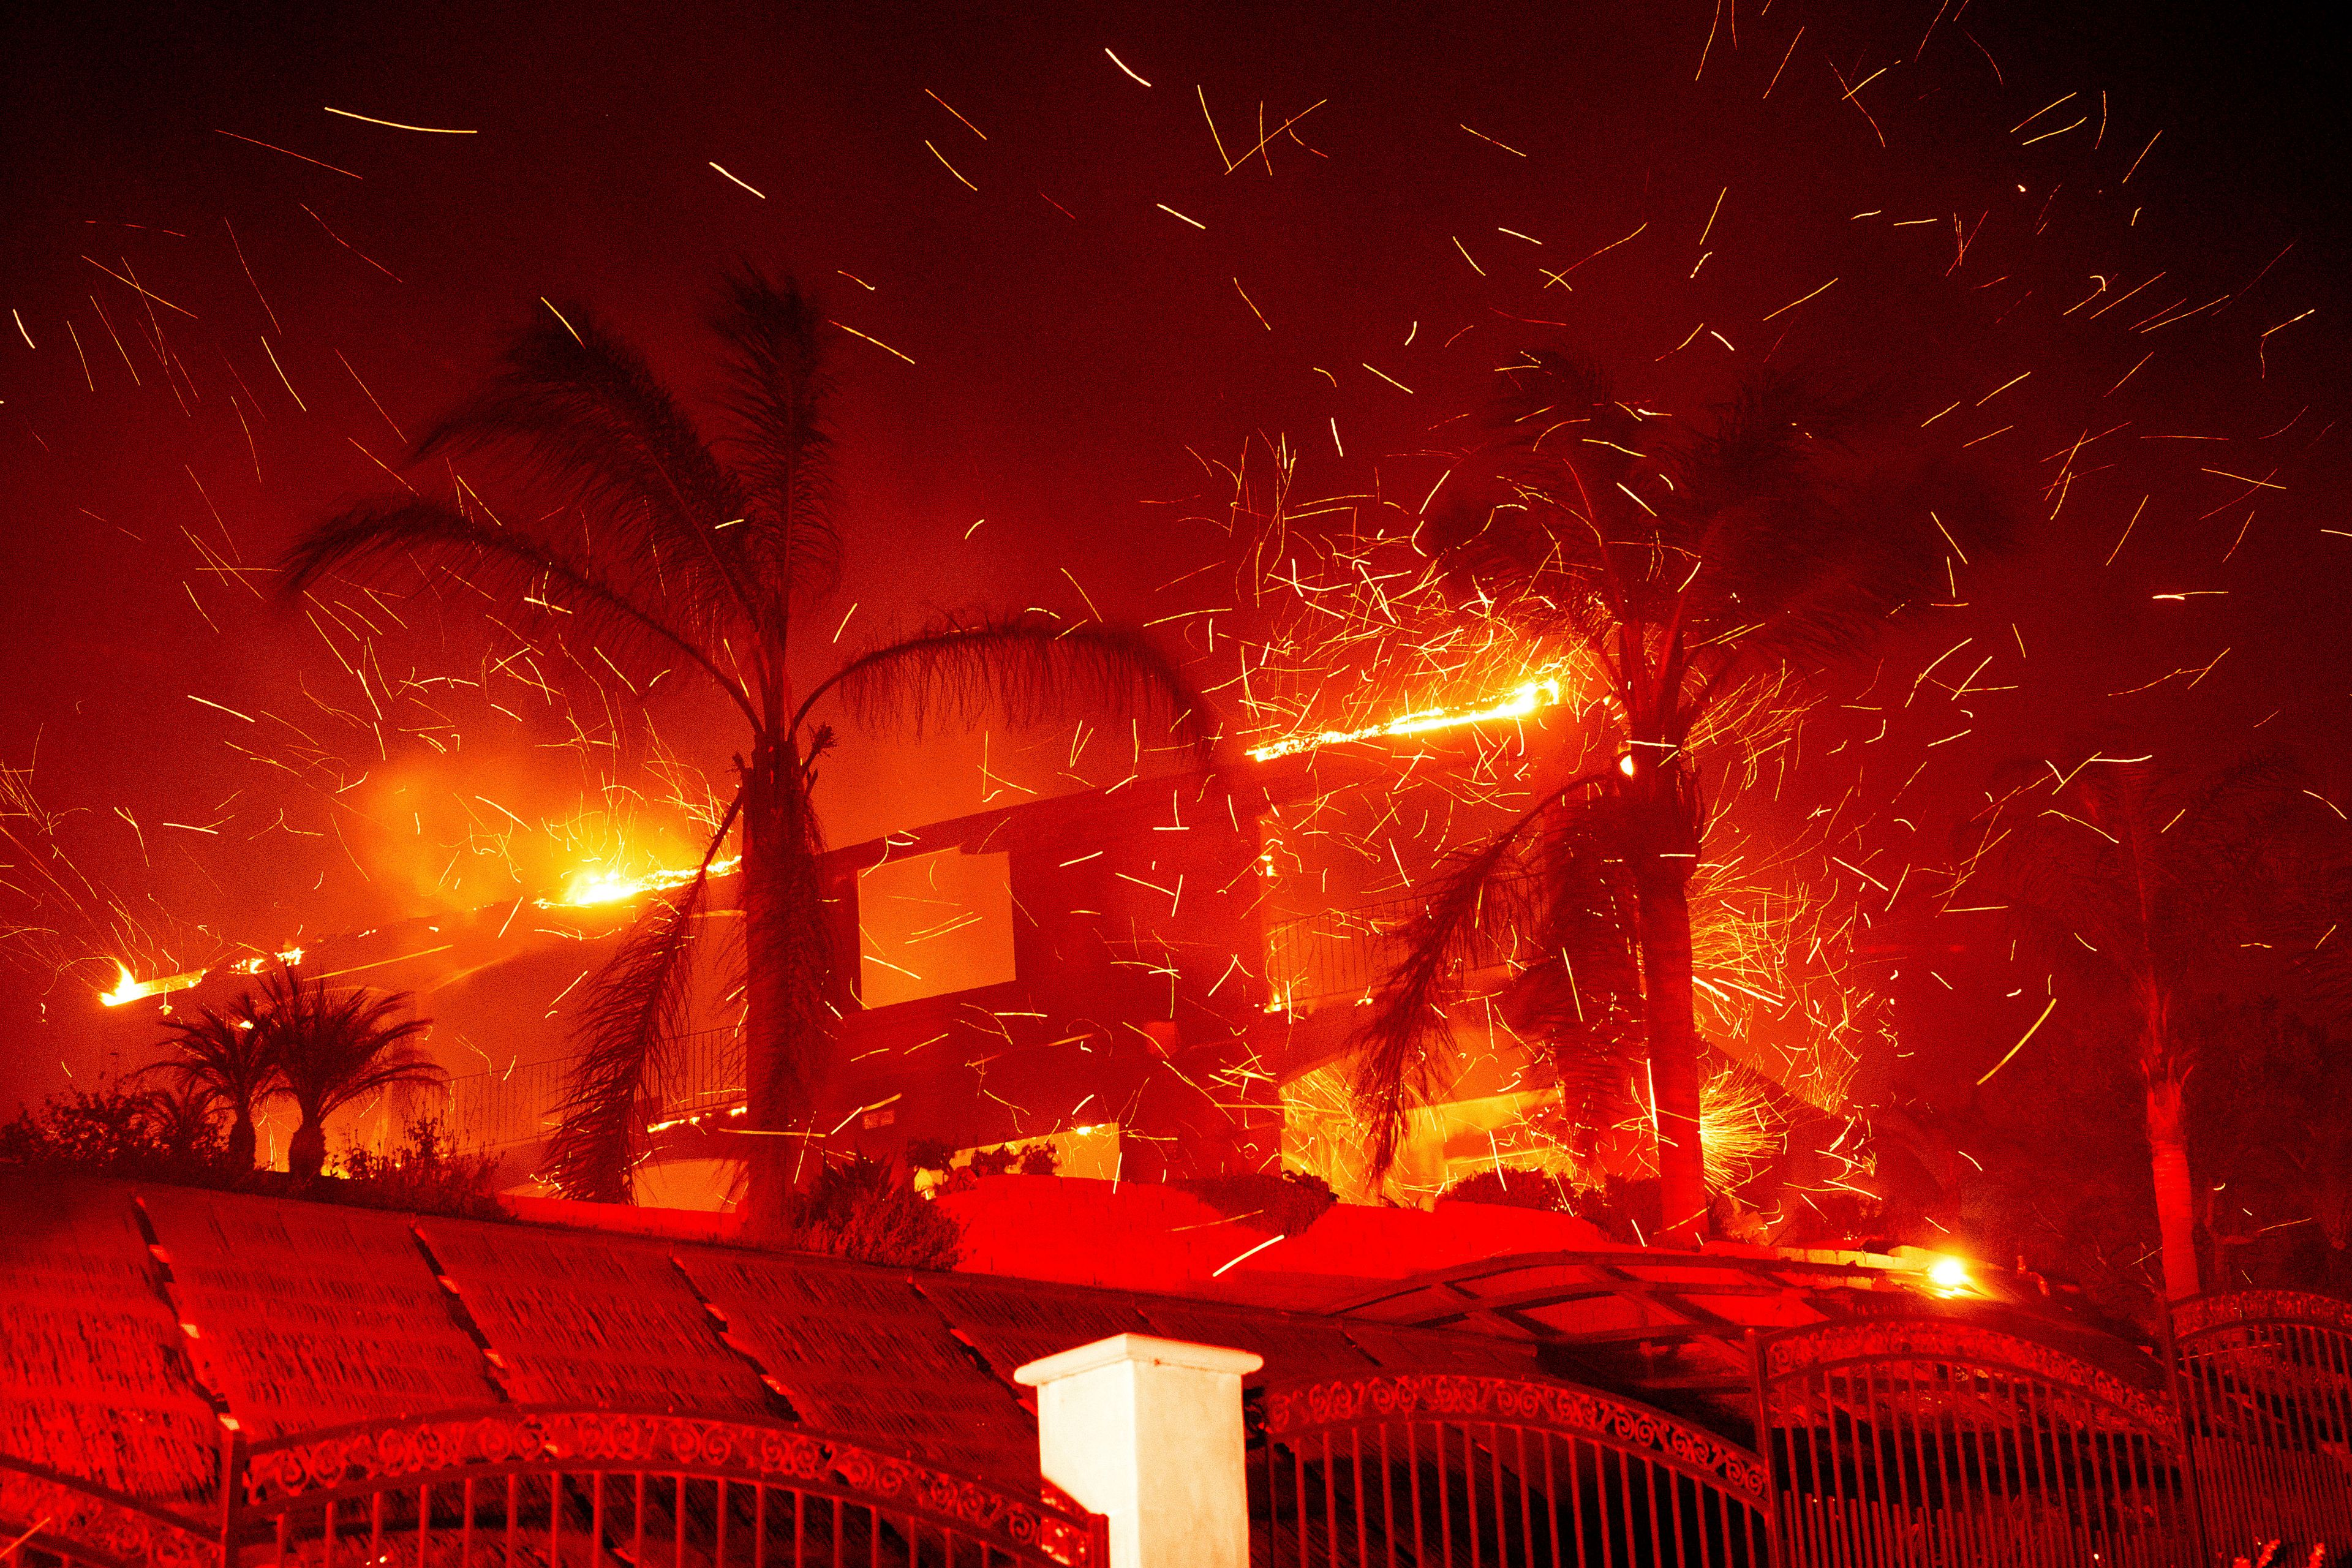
[285,273,1199,1237]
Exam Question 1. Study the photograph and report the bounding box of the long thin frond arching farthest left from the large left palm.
[280,496,760,724]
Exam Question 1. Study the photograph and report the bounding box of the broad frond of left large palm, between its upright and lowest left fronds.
[414,301,755,639]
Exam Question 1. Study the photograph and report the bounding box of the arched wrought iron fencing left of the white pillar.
[0,1406,1108,1568]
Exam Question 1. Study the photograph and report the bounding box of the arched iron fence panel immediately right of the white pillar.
[1249,1373,1769,1568]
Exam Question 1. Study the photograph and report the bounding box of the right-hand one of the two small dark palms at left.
[254,966,447,1178]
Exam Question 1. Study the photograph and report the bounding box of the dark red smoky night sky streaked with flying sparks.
[0,0,2352,1105]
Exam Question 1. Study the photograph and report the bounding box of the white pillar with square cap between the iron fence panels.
[1014,1333,1265,1568]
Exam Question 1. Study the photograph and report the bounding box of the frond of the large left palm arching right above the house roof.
[800,614,1209,755]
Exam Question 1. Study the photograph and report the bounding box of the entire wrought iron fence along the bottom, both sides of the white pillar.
[13,1291,2352,1568]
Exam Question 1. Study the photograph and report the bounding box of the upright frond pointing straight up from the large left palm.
[713,270,842,609]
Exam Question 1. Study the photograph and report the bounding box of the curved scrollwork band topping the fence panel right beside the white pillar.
[1265,1373,1764,1507]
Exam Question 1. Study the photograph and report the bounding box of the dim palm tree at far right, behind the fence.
[1962,757,2316,1300]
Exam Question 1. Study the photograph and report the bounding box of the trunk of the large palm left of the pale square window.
[743,743,826,1242]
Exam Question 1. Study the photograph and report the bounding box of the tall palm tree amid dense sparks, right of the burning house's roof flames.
[1357,353,1999,1237]
